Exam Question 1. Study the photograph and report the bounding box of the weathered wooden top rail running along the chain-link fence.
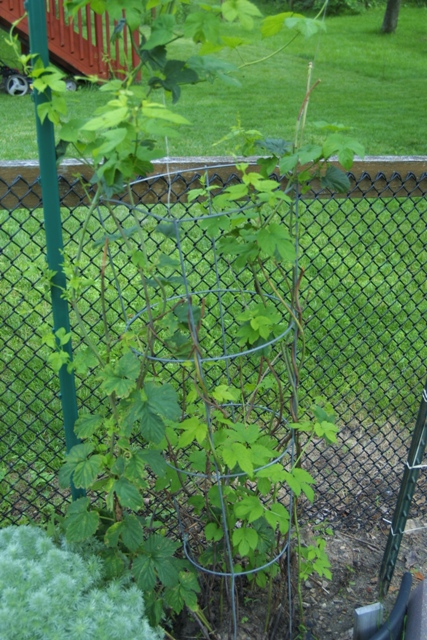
[0,156,427,210]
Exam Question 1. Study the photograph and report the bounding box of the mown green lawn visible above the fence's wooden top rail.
[0,6,427,160]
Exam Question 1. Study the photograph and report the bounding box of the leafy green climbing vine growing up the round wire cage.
[15,0,362,628]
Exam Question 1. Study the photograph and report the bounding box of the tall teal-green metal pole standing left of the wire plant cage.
[25,0,83,499]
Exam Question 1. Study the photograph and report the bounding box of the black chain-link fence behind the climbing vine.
[0,158,427,528]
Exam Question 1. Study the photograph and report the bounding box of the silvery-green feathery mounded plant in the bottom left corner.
[0,526,163,640]
